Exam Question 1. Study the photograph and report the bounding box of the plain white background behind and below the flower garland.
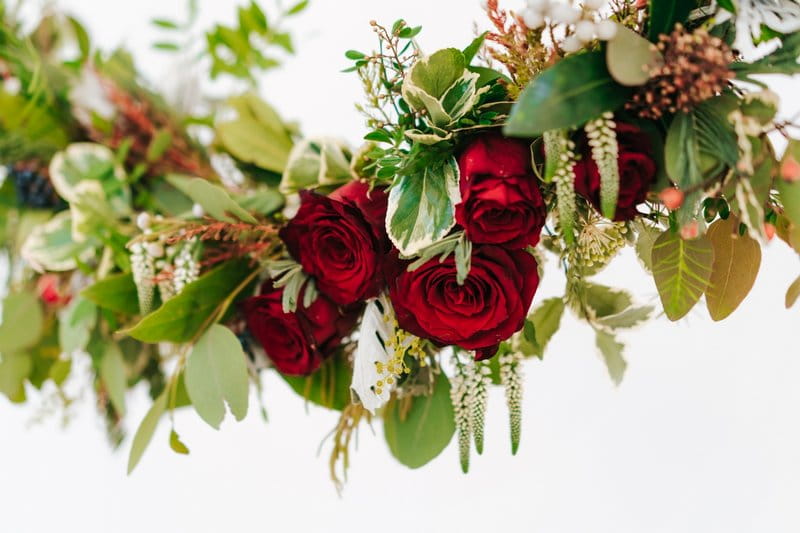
[0,0,800,533]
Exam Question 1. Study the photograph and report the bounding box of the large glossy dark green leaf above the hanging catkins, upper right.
[504,52,631,137]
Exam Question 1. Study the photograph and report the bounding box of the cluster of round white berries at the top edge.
[522,0,617,53]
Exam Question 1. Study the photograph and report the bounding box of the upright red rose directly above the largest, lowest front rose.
[456,134,547,248]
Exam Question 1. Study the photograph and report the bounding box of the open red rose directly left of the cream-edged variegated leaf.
[280,191,382,305]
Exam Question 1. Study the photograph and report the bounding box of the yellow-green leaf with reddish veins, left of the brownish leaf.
[652,230,714,321]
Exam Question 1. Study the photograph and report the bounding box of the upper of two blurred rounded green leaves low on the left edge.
[0,292,44,354]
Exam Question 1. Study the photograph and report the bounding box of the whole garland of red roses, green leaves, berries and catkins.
[0,0,800,483]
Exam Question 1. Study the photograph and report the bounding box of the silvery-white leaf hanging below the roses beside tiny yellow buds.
[350,295,394,415]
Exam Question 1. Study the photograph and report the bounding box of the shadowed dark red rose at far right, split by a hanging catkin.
[574,122,656,222]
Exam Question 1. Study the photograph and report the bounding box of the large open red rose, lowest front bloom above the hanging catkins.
[389,245,539,359]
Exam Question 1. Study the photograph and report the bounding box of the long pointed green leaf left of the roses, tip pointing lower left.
[125,260,252,344]
